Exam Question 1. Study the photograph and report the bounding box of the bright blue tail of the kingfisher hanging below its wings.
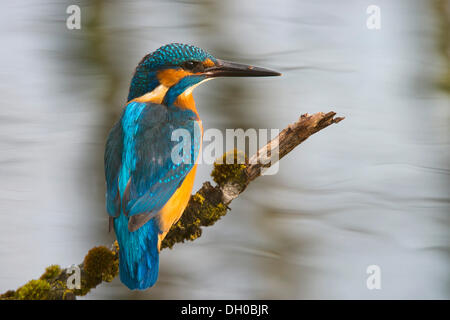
[114,214,159,290]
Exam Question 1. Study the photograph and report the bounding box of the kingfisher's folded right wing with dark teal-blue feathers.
[125,102,201,216]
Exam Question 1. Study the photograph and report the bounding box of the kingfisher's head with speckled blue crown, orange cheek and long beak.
[128,43,280,105]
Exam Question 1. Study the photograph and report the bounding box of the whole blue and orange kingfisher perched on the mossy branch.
[104,43,280,290]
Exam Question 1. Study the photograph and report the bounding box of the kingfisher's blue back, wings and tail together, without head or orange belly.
[105,102,201,289]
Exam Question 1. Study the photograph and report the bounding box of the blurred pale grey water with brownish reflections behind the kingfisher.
[0,0,450,299]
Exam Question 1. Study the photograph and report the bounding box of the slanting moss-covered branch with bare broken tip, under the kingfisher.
[0,112,344,300]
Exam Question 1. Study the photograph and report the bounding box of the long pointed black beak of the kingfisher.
[204,59,281,78]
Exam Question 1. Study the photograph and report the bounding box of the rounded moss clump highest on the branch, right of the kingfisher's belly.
[211,149,248,187]
